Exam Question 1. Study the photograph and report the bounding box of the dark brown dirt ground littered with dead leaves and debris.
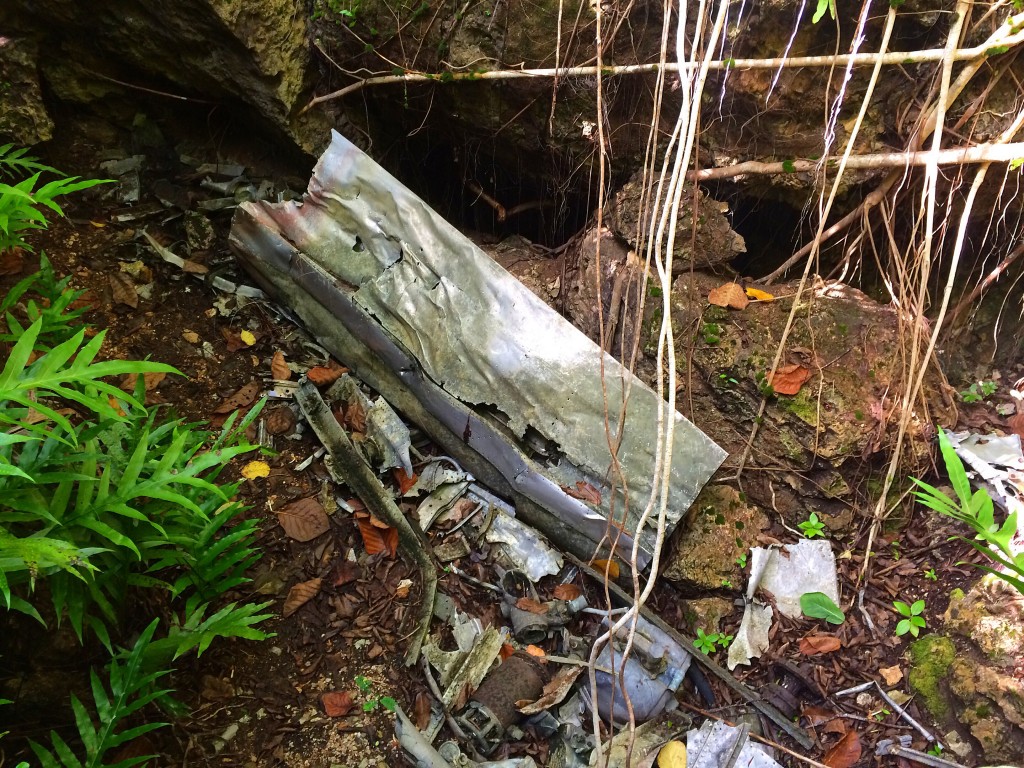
[0,115,1007,768]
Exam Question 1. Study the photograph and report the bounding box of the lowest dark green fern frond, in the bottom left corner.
[30,620,170,768]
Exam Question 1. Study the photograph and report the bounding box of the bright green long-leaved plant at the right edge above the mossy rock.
[910,429,1024,595]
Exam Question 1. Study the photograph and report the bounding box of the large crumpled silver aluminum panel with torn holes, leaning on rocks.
[230,132,725,567]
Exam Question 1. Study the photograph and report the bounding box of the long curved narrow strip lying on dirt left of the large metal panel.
[295,379,437,667]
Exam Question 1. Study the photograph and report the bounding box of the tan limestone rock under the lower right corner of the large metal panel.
[662,485,768,592]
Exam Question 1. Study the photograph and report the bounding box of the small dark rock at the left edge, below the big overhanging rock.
[0,36,53,146]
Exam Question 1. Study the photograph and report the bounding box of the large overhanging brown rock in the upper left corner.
[0,0,327,151]
